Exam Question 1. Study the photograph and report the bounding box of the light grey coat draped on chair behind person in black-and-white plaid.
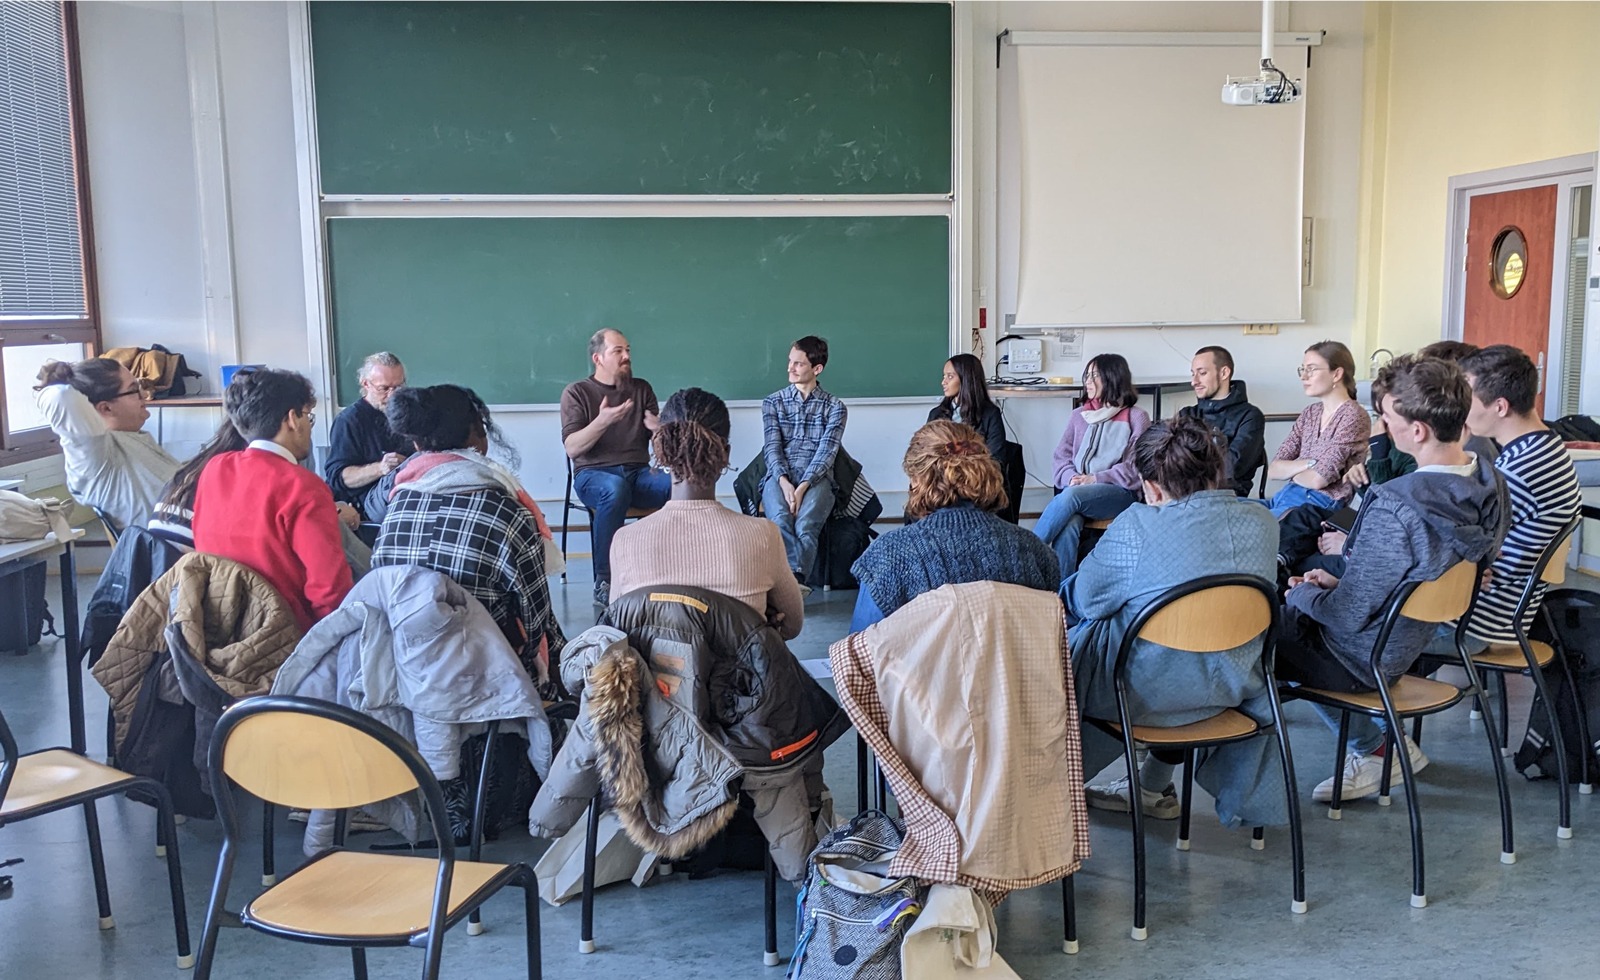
[272,565,552,852]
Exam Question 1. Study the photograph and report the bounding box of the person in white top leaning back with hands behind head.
[34,357,179,532]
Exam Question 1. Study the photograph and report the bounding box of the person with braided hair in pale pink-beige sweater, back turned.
[611,388,805,639]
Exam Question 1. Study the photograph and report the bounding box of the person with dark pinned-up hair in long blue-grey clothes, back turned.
[1061,418,1288,823]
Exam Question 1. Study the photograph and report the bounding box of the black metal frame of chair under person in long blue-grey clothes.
[1062,575,1306,953]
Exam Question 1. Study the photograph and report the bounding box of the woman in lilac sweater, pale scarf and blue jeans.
[1034,354,1150,578]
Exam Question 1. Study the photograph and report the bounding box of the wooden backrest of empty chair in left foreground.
[222,711,418,810]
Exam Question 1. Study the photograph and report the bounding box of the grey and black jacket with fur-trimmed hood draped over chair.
[528,586,850,881]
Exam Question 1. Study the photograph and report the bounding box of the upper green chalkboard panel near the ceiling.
[309,2,950,195]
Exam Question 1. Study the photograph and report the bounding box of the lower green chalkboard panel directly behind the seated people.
[328,216,950,405]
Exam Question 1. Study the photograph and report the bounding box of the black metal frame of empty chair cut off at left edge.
[0,713,194,969]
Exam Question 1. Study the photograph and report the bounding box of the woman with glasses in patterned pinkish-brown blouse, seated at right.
[1267,341,1373,517]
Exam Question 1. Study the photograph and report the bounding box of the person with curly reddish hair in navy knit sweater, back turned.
[850,420,1061,633]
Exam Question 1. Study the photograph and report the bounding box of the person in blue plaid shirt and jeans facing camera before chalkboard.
[762,336,846,588]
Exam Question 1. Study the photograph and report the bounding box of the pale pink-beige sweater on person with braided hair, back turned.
[611,500,805,639]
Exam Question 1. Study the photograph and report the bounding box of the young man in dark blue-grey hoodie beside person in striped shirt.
[1277,357,1509,801]
